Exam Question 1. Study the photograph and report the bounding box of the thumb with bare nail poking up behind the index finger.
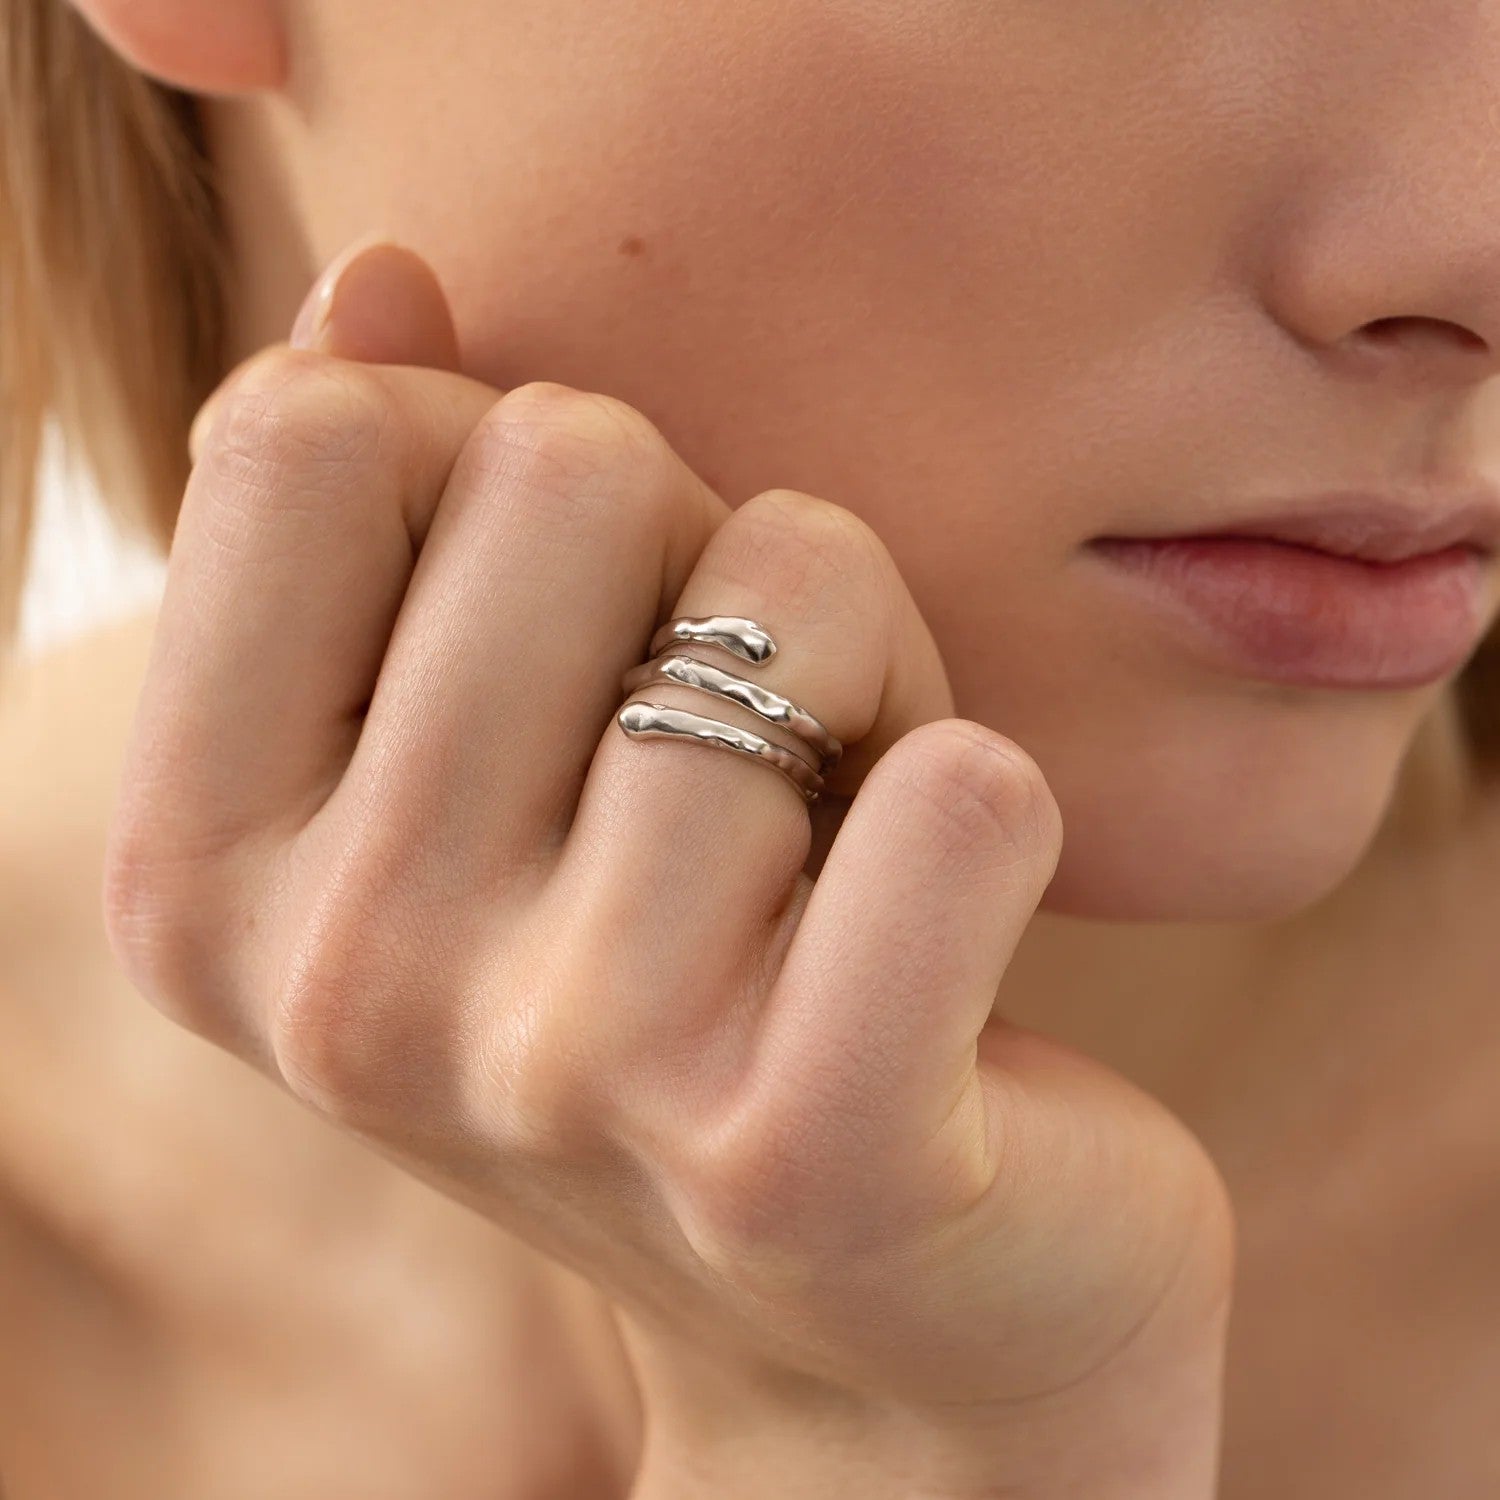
[188,234,461,462]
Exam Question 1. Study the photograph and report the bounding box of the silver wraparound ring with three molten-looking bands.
[615,615,843,804]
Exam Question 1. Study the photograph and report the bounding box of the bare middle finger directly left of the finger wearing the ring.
[319,381,729,896]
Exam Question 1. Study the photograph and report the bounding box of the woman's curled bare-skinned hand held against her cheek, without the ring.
[104,246,1232,1500]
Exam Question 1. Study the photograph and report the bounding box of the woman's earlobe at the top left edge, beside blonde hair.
[72,0,287,95]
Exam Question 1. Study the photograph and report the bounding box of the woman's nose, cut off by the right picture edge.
[1263,41,1500,395]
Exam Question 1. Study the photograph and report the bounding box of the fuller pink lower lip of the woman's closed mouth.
[1091,536,1488,687]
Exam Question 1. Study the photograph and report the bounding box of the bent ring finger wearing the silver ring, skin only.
[554,489,953,1068]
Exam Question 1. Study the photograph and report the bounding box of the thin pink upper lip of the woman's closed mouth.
[1116,483,1500,563]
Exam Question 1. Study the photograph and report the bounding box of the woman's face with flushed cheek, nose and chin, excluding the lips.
[231,0,1500,918]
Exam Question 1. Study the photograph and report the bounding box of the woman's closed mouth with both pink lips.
[1088,488,1500,689]
